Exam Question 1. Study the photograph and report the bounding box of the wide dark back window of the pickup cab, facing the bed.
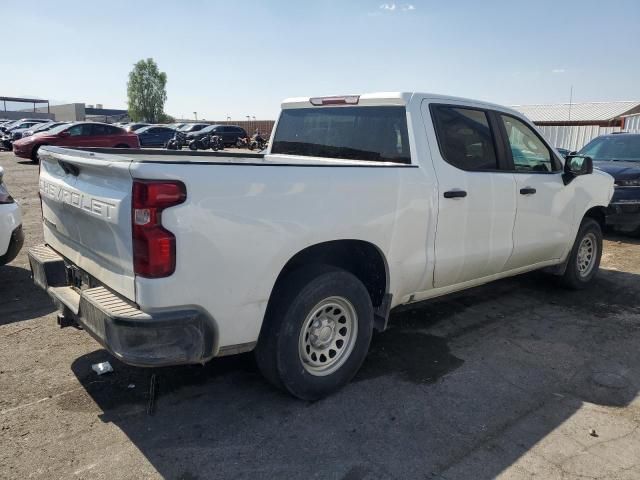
[271,106,411,163]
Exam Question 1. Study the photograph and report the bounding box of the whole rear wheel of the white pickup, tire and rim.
[255,265,373,400]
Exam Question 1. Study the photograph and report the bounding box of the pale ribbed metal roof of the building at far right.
[512,100,640,122]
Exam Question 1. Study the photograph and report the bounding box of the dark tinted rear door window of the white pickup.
[431,105,498,170]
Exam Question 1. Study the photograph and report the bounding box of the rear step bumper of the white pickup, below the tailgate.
[28,245,215,367]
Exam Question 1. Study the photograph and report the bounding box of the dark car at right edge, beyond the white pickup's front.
[578,133,640,235]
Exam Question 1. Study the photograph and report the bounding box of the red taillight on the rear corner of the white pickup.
[131,180,187,278]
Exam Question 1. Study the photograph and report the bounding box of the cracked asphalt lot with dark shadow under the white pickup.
[0,153,640,480]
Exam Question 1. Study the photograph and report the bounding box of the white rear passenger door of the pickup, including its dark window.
[422,100,516,288]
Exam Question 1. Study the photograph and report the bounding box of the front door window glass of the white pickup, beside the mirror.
[500,115,557,172]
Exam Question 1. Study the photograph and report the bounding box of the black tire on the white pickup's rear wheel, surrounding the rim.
[255,265,373,401]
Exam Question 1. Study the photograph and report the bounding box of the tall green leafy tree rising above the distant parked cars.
[127,58,167,123]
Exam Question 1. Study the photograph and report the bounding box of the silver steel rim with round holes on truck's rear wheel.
[298,296,358,377]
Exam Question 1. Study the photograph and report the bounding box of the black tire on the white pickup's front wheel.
[561,217,602,290]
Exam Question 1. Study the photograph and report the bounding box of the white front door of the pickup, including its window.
[496,114,574,269]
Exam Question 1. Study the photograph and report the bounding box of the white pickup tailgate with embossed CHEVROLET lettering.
[39,147,135,300]
